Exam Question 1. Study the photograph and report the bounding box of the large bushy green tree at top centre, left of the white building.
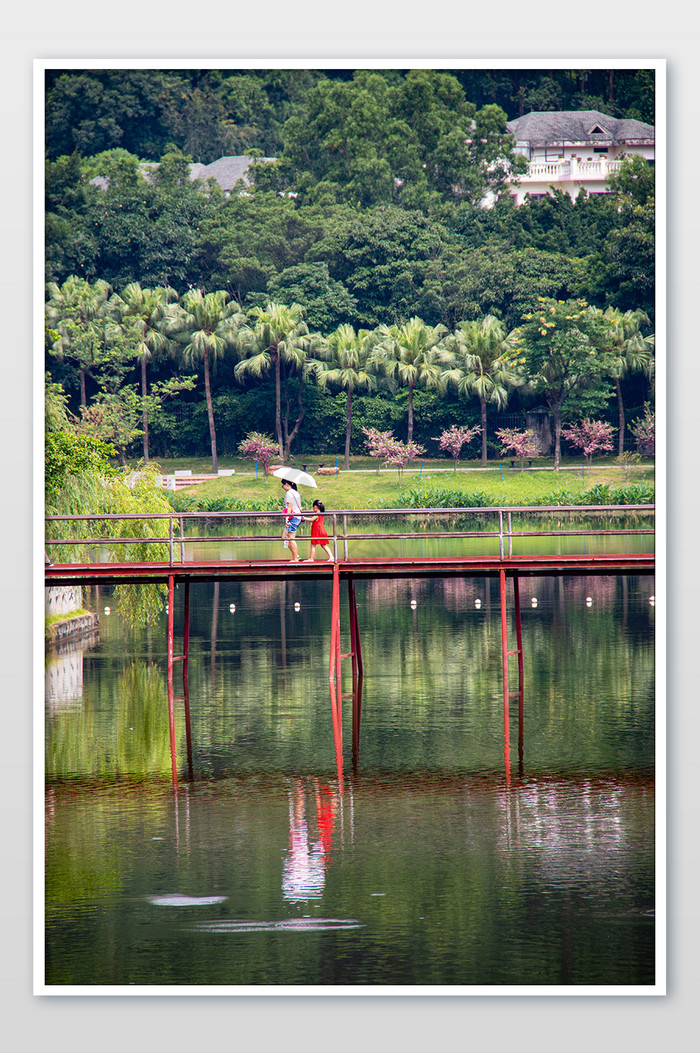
[267,69,525,212]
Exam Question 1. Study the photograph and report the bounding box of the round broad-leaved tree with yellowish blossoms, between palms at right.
[508,297,609,471]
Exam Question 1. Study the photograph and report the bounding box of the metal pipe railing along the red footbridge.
[45,504,655,565]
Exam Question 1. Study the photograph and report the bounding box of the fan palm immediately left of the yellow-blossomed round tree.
[445,315,520,464]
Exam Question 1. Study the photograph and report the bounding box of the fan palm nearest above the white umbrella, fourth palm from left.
[235,303,319,461]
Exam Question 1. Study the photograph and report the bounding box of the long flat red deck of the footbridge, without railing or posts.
[45,553,656,587]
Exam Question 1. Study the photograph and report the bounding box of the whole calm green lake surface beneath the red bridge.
[45,577,656,993]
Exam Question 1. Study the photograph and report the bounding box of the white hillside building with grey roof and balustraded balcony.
[507,110,655,204]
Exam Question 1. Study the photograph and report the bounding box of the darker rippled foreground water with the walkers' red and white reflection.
[47,773,654,993]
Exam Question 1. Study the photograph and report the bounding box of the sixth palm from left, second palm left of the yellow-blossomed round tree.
[367,317,453,442]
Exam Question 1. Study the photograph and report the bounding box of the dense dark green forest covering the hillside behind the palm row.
[45,68,655,456]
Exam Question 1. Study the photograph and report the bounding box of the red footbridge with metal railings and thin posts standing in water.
[45,505,656,781]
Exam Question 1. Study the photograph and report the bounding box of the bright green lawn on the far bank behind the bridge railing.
[143,456,654,510]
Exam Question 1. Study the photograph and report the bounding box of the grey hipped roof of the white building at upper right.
[506,110,654,145]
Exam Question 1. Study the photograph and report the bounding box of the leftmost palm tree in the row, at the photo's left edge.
[45,274,112,409]
